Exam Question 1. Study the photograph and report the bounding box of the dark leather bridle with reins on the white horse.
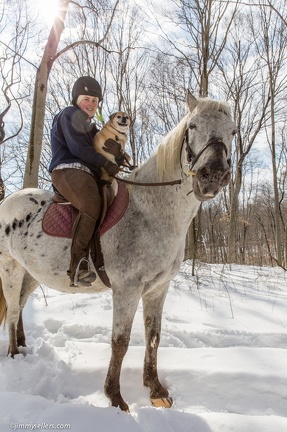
[114,129,228,187]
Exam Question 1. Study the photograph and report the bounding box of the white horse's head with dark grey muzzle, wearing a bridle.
[184,92,236,201]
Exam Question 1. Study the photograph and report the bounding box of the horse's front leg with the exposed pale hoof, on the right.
[143,283,173,408]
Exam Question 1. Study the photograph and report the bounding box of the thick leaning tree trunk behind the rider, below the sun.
[23,0,70,188]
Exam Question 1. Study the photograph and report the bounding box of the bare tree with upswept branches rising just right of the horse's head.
[218,8,270,263]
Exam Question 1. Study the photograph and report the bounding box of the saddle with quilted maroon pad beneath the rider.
[42,182,129,288]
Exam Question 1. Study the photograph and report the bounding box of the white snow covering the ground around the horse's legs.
[0,262,287,432]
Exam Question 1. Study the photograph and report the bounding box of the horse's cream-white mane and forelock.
[156,98,231,181]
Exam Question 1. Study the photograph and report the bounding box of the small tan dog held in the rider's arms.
[93,111,131,195]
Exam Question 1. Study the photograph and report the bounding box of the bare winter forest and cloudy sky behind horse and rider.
[0,0,287,268]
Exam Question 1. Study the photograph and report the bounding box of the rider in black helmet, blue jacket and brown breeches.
[49,76,122,285]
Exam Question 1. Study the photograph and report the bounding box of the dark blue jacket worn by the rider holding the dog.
[49,106,107,174]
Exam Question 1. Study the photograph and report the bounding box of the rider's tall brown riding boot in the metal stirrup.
[67,213,97,286]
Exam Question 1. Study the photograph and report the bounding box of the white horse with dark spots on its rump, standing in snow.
[0,92,236,412]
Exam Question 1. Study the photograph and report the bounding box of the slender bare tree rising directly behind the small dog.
[104,1,150,165]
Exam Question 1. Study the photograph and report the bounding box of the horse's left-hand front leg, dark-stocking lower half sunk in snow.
[105,288,140,412]
